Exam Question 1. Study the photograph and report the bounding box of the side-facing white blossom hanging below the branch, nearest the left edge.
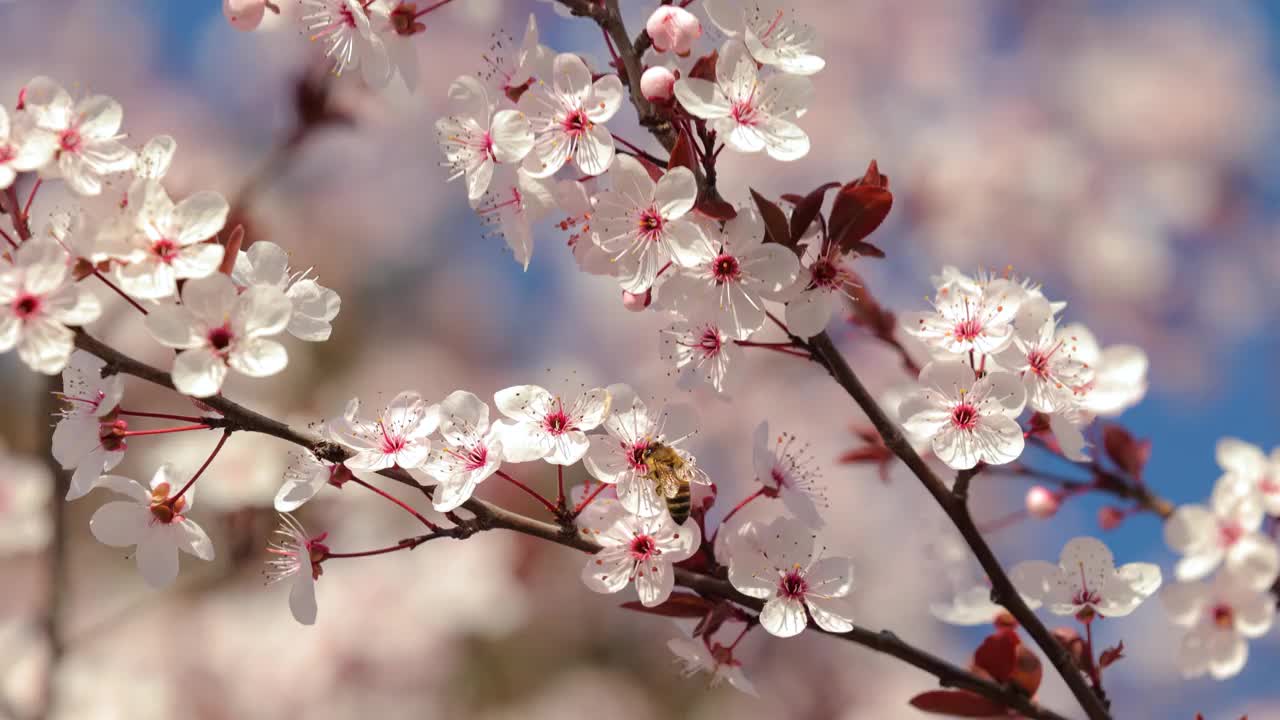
[52,350,128,500]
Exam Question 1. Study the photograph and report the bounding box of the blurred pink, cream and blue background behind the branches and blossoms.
[0,0,1280,720]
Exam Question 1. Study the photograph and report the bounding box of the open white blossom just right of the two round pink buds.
[676,40,813,161]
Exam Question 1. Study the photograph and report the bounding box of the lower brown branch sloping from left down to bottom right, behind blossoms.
[67,331,1065,720]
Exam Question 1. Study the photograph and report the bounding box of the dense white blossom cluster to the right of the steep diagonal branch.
[897,268,1147,470]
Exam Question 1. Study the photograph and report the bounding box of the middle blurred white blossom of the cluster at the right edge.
[1165,475,1280,589]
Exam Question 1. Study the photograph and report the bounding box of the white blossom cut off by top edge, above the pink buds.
[703,0,827,76]
